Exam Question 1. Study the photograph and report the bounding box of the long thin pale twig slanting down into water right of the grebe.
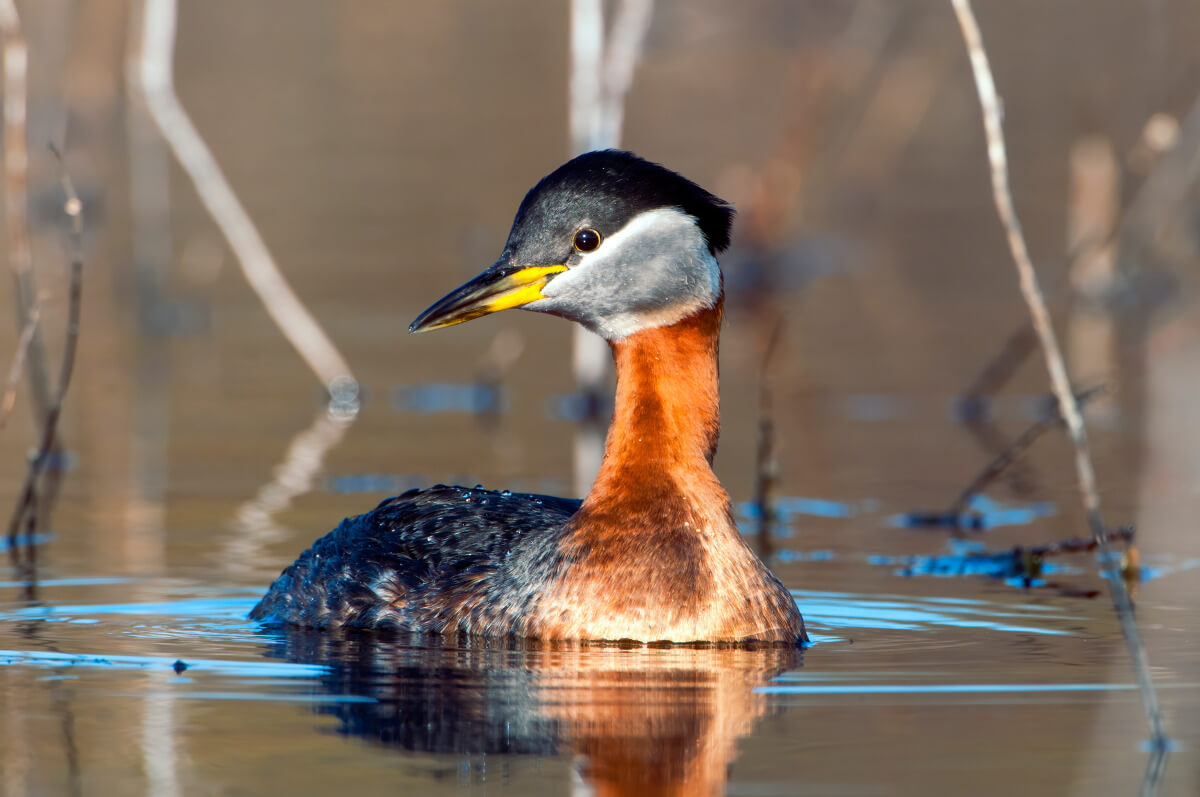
[950,0,1166,748]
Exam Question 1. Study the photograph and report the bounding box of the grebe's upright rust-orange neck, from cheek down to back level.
[586,300,724,504]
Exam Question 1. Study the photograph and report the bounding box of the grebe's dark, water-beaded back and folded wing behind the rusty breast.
[250,485,580,634]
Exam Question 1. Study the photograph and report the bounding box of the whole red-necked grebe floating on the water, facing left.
[251,150,806,643]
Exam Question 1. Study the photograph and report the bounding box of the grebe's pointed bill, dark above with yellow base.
[408,263,566,332]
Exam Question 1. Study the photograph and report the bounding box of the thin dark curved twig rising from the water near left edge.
[8,145,83,568]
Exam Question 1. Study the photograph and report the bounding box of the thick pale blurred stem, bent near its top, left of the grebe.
[140,0,358,397]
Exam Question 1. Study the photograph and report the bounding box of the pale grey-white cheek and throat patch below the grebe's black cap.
[537,208,721,340]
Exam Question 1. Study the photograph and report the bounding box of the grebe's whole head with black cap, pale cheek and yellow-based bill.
[408,150,733,341]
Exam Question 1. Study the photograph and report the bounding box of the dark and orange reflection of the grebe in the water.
[268,628,802,797]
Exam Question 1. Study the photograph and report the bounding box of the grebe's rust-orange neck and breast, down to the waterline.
[529,304,803,642]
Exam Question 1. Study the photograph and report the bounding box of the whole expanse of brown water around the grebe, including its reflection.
[0,0,1200,797]
